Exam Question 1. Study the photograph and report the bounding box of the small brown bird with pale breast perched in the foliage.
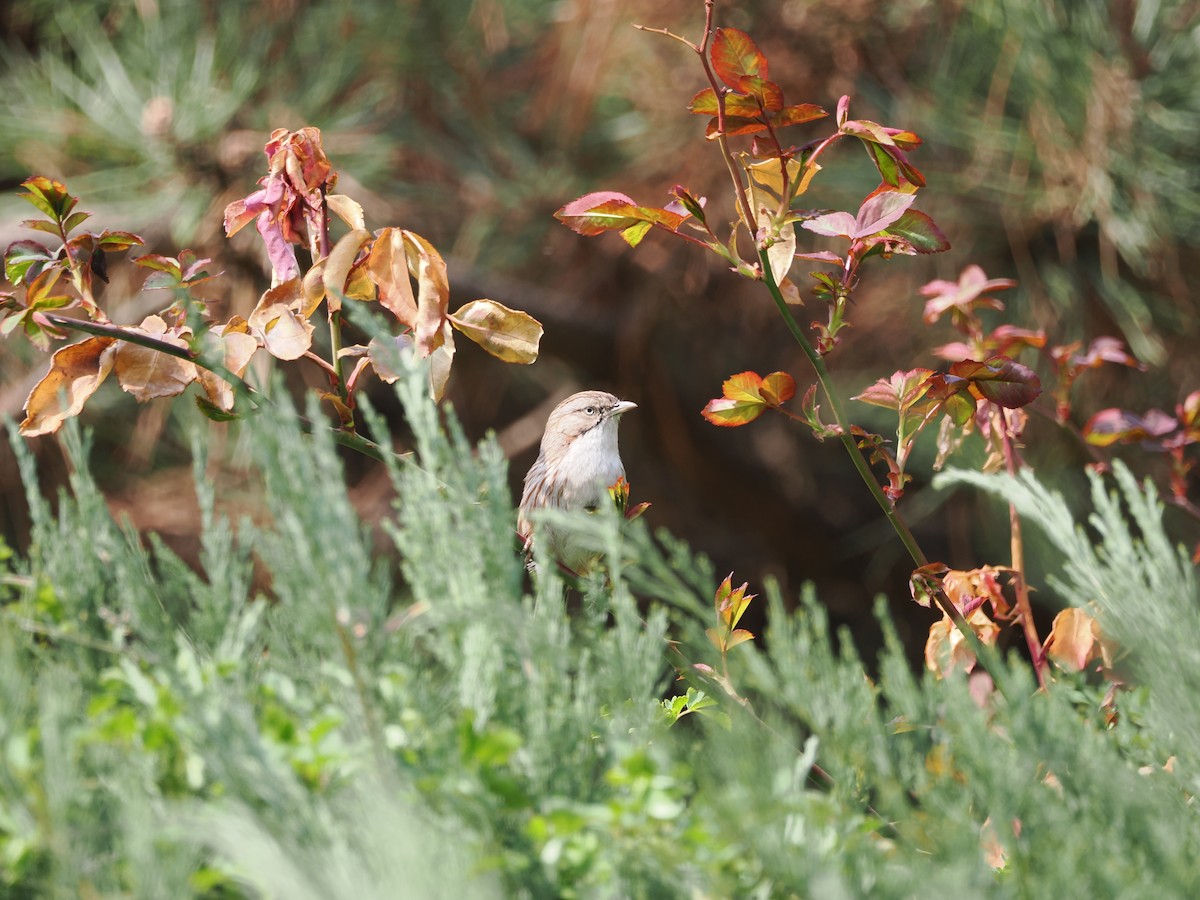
[517,391,637,572]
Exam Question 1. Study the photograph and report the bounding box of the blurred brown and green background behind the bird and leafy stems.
[0,0,1200,652]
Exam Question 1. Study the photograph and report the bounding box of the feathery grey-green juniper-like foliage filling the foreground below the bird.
[0,362,1200,898]
